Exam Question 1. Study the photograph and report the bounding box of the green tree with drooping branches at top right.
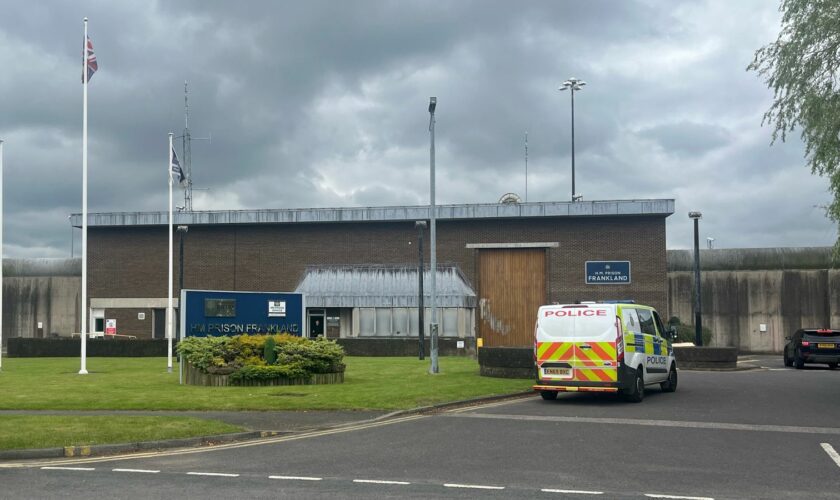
[747,0,840,236]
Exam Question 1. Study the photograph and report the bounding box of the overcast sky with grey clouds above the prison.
[0,0,837,257]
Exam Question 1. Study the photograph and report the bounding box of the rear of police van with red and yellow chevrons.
[536,304,618,385]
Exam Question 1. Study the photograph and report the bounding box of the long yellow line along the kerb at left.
[0,415,428,469]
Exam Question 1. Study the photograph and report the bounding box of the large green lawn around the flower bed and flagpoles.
[0,357,533,412]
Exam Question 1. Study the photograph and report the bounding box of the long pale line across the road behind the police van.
[452,413,840,435]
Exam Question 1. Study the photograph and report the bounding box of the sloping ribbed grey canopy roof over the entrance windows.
[295,265,476,307]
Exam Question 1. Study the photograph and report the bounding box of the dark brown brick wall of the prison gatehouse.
[88,216,667,336]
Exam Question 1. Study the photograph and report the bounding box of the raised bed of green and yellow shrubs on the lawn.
[178,335,345,386]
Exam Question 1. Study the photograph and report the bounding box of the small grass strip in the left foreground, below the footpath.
[0,416,242,450]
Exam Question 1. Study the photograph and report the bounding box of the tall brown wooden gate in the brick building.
[478,248,546,347]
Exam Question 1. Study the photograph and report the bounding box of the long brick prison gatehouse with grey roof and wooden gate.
[71,199,674,346]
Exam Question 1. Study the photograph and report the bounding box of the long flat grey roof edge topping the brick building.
[70,199,674,227]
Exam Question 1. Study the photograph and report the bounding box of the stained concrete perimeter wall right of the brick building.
[668,248,840,353]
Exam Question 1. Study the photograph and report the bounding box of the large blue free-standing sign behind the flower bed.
[181,290,304,337]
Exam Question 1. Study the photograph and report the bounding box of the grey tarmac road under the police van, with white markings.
[0,357,840,499]
